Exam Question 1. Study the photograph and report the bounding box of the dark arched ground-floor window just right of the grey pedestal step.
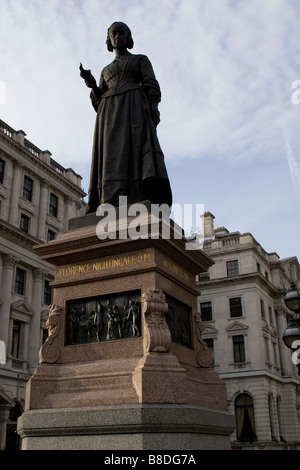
[235,393,256,441]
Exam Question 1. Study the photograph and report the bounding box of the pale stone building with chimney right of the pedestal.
[198,212,300,449]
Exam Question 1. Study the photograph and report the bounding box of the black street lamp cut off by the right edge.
[282,282,300,375]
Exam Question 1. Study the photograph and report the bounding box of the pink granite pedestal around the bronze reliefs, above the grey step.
[26,215,227,410]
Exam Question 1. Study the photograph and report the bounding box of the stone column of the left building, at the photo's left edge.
[0,253,18,355]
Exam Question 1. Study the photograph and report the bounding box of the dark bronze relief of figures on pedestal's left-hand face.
[66,291,141,345]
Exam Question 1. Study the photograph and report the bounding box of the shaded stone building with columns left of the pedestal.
[0,120,85,449]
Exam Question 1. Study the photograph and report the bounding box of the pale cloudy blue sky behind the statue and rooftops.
[0,0,300,260]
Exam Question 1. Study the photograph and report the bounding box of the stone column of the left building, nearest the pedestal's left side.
[28,269,46,374]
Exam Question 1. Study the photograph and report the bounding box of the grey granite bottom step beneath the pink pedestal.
[18,404,233,452]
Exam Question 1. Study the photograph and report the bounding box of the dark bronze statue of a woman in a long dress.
[80,22,172,214]
